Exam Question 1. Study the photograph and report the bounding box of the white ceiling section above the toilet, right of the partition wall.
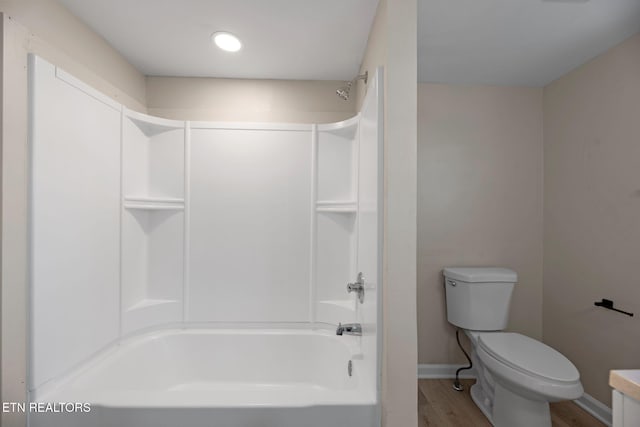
[418,0,640,86]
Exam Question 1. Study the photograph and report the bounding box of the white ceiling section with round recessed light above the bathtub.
[60,0,378,80]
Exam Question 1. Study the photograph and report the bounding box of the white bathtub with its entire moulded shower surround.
[29,56,382,427]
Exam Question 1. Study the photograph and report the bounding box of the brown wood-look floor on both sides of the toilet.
[418,379,604,427]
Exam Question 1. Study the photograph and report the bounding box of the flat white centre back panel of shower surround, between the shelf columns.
[186,128,312,322]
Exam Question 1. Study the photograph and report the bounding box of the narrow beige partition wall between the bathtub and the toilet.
[358,0,418,427]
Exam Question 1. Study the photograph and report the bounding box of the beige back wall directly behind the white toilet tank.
[418,84,543,364]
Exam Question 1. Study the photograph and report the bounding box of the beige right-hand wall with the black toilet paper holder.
[543,34,640,404]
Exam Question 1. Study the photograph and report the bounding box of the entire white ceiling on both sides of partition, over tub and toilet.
[60,0,640,86]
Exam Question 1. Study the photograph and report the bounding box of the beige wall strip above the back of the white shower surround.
[147,77,356,123]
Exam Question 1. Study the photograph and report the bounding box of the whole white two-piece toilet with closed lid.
[444,267,583,427]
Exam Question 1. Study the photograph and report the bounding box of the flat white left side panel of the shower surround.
[29,57,120,389]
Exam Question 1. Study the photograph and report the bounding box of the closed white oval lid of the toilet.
[478,332,580,384]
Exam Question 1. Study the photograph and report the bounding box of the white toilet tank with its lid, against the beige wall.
[443,267,518,331]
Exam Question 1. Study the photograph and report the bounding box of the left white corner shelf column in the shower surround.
[121,109,187,333]
